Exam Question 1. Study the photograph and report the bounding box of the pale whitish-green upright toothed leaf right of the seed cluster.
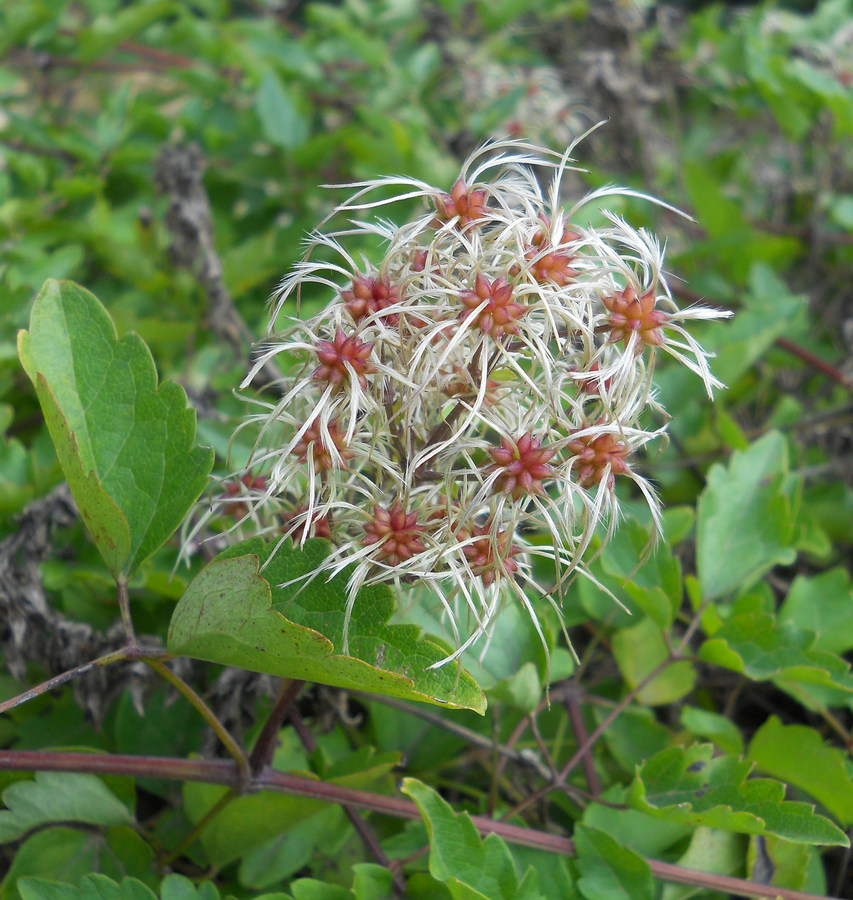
[696,432,795,600]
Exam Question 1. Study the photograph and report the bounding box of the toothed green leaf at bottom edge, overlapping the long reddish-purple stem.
[401,778,538,900]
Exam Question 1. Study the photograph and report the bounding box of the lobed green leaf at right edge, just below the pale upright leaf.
[698,611,853,694]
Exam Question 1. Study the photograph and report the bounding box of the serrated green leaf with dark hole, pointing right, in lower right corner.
[628,744,848,846]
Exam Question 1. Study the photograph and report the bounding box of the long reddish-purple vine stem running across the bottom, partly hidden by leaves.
[0,750,840,900]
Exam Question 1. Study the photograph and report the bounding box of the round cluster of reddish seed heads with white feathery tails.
[233,142,719,659]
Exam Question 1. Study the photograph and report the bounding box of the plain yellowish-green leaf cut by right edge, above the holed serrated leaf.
[748,716,853,826]
